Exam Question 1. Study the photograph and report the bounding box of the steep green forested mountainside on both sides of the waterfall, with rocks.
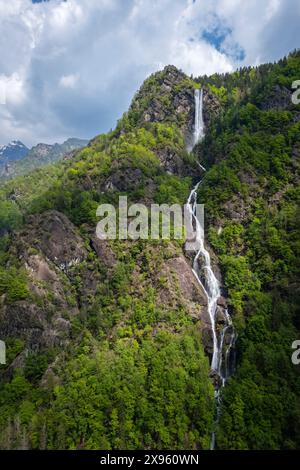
[0,51,300,449]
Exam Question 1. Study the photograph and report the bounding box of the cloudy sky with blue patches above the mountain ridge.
[0,0,300,146]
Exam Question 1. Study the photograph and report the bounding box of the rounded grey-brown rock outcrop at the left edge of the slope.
[0,211,87,360]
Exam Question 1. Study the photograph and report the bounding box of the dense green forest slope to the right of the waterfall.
[199,52,300,449]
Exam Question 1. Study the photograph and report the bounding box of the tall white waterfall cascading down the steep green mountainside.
[187,89,236,450]
